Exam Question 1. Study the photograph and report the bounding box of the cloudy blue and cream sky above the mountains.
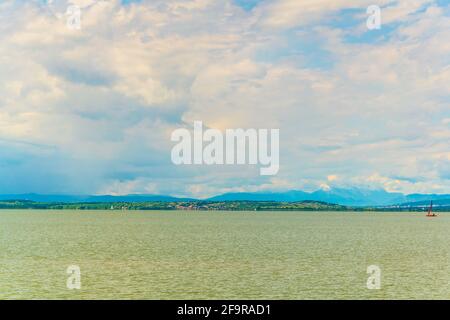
[0,0,450,197]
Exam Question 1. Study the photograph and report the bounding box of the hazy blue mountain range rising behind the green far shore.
[0,188,450,206]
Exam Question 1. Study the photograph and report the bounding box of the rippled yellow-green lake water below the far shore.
[0,210,450,299]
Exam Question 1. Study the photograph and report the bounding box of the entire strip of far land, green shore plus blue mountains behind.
[0,188,450,211]
